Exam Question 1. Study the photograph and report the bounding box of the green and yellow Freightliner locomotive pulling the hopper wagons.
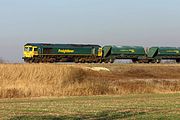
[23,43,102,63]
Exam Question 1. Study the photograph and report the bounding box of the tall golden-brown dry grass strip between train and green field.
[0,64,180,98]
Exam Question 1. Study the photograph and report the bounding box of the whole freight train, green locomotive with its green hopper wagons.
[23,43,180,63]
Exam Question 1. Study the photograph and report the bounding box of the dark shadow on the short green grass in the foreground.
[10,111,146,120]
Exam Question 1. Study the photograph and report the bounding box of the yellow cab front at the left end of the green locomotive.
[24,46,38,58]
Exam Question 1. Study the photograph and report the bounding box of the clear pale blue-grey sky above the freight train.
[0,0,180,62]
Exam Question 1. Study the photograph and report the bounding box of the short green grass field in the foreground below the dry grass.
[0,93,180,120]
